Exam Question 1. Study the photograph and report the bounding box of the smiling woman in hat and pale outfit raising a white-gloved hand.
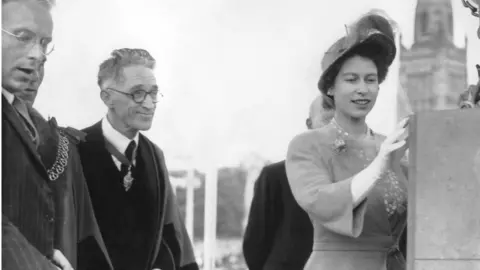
[286,11,407,270]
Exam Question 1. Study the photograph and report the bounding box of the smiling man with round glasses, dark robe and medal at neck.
[80,49,198,270]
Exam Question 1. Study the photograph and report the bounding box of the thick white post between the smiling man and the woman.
[203,166,218,270]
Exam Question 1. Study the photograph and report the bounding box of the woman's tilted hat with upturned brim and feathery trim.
[318,12,397,94]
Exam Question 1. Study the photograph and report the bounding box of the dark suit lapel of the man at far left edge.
[2,95,48,176]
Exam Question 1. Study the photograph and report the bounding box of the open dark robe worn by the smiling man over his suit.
[79,121,198,270]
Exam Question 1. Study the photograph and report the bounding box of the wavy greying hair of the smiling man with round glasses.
[97,48,156,88]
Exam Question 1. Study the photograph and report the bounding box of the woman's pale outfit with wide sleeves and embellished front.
[286,122,407,270]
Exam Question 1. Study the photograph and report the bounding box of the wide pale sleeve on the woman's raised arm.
[286,133,367,238]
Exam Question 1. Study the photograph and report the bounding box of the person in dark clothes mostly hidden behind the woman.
[243,96,333,270]
